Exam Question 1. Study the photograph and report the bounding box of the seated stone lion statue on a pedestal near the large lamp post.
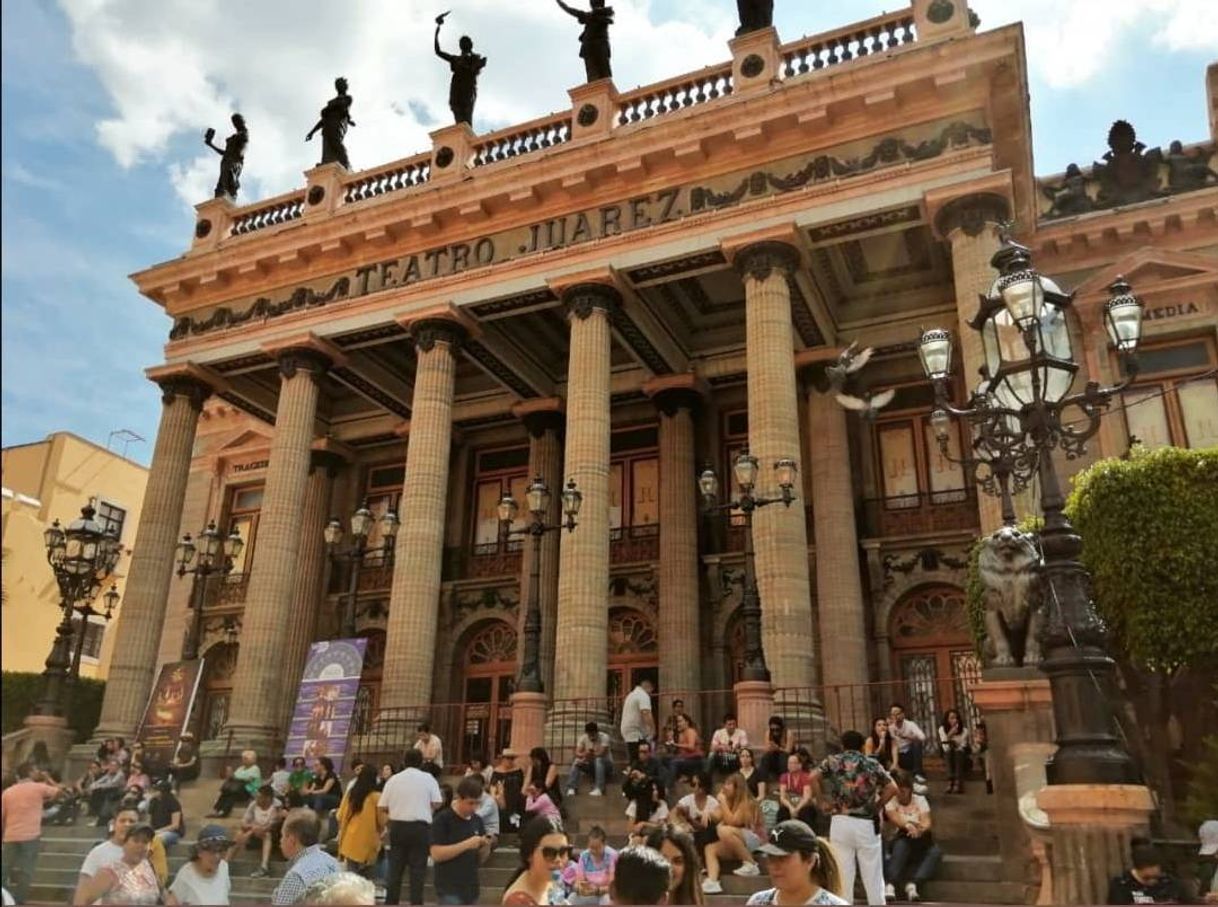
[977,526,1043,667]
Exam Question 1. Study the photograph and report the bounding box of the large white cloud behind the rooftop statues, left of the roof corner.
[60,0,734,205]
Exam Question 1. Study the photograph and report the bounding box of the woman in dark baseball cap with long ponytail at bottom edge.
[748,819,850,907]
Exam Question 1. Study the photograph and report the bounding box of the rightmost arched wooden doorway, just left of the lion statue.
[888,586,980,734]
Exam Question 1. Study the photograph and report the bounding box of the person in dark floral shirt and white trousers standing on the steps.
[812,730,896,903]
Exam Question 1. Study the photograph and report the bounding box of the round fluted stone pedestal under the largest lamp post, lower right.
[1037,784,1155,903]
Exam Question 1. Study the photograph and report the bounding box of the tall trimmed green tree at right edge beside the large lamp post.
[1066,448,1218,816]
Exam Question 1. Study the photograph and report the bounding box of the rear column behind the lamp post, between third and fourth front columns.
[516,413,565,693]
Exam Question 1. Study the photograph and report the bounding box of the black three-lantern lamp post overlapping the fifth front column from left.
[698,450,798,683]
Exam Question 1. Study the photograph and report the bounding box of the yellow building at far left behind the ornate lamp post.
[0,432,147,678]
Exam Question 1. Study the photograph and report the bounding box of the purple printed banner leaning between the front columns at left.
[284,639,368,772]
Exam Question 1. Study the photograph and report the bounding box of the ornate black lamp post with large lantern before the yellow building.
[34,502,122,716]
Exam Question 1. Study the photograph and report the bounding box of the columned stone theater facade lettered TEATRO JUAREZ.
[88,0,1218,761]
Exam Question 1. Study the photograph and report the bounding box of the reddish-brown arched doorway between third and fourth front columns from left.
[449,620,516,763]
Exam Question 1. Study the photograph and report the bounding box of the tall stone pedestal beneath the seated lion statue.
[971,668,1054,884]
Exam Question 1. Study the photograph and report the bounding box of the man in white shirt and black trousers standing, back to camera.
[378,749,445,903]
